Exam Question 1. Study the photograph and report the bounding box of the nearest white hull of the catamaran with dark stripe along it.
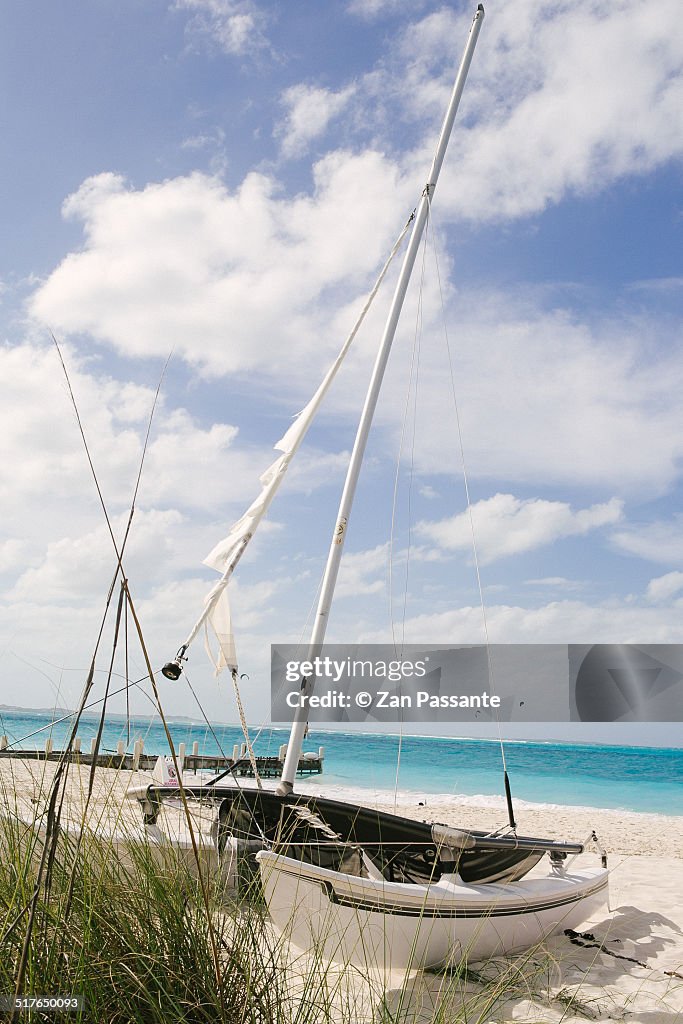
[257,851,608,970]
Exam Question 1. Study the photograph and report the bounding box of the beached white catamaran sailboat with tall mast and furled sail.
[136,5,608,968]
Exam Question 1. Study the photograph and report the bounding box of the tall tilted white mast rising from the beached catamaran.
[278,4,483,796]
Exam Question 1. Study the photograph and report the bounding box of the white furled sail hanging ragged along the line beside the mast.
[178,214,414,675]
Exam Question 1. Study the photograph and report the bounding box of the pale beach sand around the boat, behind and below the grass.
[0,758,683,1024]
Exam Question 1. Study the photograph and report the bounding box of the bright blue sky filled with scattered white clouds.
[0,0,683,744]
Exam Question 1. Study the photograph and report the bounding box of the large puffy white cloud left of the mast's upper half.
[31,160,408,375]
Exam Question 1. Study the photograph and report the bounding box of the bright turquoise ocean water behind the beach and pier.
[0,711,683,815]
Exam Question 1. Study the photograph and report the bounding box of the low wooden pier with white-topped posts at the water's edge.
[0,736,325,778]
